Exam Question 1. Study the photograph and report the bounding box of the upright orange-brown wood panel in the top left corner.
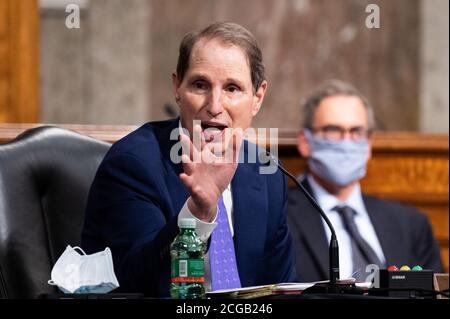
[0,0,39,123]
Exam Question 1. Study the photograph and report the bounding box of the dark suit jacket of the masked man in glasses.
[288,179,443,282]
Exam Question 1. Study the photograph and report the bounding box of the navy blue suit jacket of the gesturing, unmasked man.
[82,120,296,297]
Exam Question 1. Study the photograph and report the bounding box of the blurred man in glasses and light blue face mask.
[288,80,442,282]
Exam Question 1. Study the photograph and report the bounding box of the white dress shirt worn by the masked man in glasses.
[306,175,386,278]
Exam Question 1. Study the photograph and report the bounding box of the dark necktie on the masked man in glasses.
[334,206,382,281]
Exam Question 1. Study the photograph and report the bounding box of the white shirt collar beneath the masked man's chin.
[306,174,366,214]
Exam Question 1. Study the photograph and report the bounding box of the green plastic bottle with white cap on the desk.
[170,218,205,299]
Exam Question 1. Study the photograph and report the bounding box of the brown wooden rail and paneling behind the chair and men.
[0,124,449,272]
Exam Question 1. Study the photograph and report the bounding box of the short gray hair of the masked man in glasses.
[302,80,375,130]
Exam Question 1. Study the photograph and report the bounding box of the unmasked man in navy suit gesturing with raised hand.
[82,23,296,297]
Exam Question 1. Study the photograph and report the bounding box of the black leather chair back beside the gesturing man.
[0,126,110,298]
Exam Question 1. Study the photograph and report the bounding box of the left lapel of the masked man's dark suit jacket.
[296,178,329,277]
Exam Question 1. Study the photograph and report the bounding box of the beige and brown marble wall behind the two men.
[41,0,448,132]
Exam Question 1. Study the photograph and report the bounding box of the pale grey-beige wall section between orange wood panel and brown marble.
[41,0,152,124]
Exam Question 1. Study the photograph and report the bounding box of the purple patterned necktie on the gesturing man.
[209,197,241,291]
